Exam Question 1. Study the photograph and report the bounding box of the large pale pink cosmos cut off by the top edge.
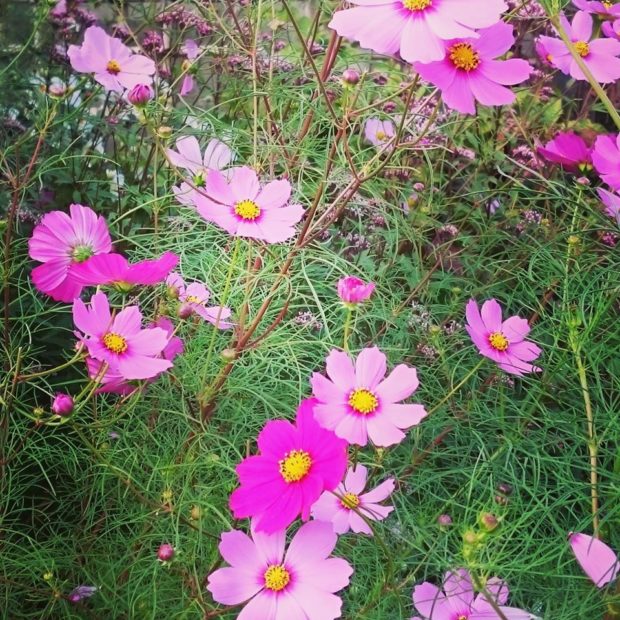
[329,0,507,62]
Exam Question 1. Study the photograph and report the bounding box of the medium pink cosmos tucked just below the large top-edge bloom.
[415,22,532,114]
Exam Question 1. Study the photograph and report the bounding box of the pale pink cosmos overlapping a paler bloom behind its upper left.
[193,166,304,243]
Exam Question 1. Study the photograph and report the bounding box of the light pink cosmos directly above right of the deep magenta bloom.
[310,347,427,446]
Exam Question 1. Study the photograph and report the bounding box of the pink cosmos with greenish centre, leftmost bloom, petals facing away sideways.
[28,204,112,302]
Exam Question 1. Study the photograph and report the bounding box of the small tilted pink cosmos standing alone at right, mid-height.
[465,299,541,375]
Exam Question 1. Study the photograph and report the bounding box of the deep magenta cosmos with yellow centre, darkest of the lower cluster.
[230,399,347,534]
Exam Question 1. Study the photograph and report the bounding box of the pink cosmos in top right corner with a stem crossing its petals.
[540,11,620,84]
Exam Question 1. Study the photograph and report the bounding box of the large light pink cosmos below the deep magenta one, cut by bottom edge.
[207,521,353,620]
